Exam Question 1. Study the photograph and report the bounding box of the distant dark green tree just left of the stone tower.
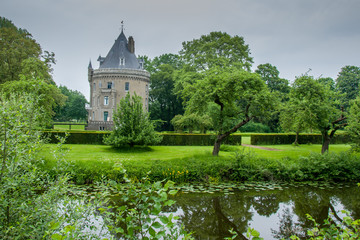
[54,86,88,121]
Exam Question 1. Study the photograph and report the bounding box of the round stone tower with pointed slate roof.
[86,30,150,130]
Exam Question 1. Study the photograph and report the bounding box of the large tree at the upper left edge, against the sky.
[0,17,66,121]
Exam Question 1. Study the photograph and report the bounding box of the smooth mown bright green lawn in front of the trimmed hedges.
[44,144,350,161]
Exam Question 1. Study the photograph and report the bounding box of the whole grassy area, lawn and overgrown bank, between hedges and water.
[41,144,360,184]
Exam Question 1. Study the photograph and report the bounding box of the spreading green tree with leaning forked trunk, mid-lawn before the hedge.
[180,67,276,156]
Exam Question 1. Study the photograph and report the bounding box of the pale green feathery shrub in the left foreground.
[0,94,67,239]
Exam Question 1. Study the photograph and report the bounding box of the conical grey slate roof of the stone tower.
[99,31,140,69]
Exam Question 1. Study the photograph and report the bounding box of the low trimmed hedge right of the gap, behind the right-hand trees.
[251,133,351,145]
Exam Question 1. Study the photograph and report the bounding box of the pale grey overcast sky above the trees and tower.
[0,0,360,99]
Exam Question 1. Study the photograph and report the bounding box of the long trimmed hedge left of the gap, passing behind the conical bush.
[44,131,241,146]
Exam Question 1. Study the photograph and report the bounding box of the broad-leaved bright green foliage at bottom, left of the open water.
[100,167,193,239]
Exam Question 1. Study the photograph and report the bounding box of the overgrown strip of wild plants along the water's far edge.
[41,146,360,184]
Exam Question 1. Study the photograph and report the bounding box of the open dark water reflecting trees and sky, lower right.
[169,186,360,239]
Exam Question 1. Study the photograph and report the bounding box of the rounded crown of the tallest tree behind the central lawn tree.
[180,32,253,71]
